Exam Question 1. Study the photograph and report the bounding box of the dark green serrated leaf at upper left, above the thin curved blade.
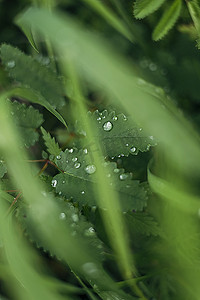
[0,44,65,109]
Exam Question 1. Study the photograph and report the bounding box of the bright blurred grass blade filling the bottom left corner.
[0,199,67,300]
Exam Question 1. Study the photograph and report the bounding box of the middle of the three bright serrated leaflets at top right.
[152,0,182,41]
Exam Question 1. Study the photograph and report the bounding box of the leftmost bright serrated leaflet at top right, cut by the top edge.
[133,0,165,19]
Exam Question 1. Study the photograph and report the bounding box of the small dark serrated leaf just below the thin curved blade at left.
[10,101,44,148]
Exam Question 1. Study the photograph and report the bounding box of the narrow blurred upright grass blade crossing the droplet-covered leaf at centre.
[62,61,146,300]
